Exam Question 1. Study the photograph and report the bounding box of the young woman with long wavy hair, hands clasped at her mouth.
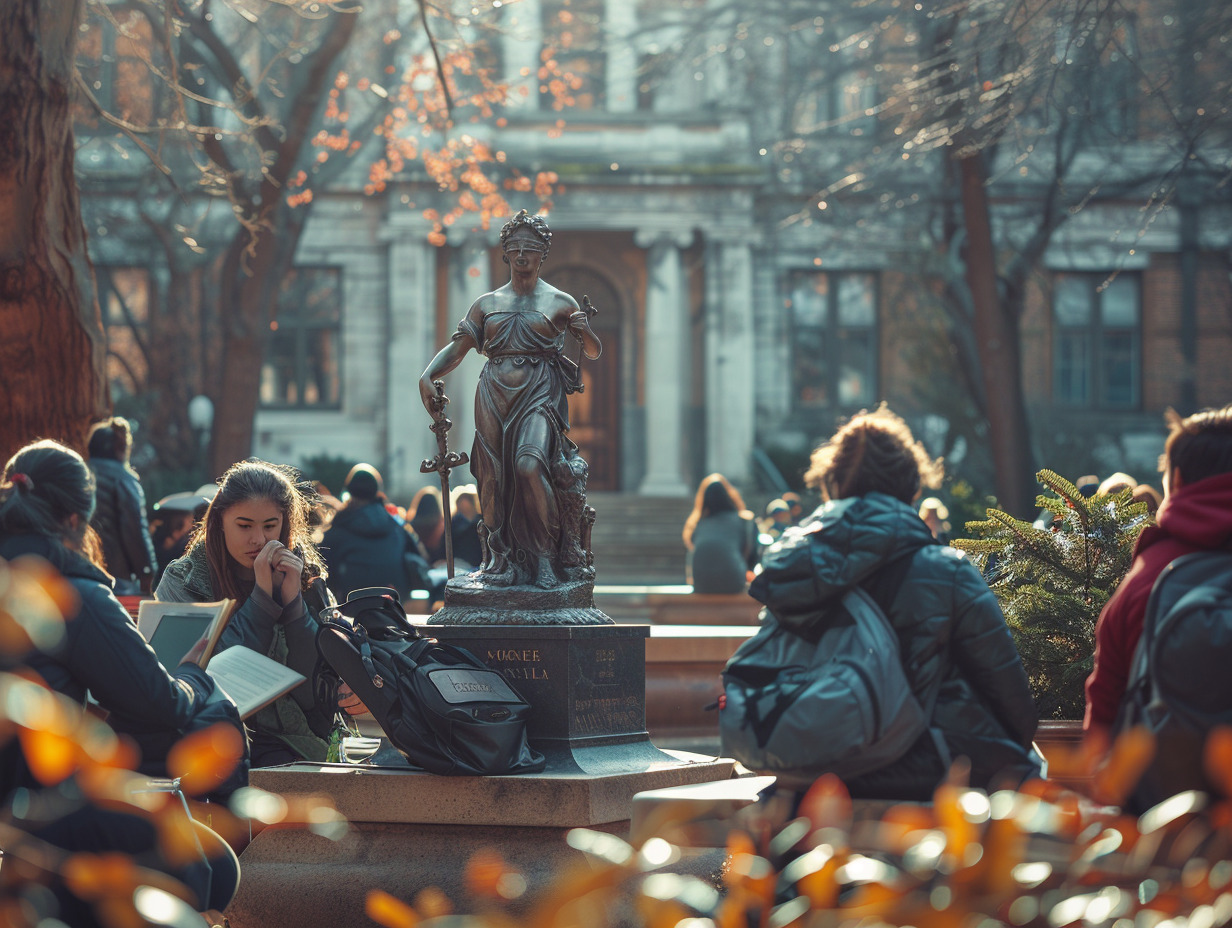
[155,461,334,767]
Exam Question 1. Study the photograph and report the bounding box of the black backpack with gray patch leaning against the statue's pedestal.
[317,590,546,776]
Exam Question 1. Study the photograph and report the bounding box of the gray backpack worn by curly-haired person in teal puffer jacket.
[718,552,931,786]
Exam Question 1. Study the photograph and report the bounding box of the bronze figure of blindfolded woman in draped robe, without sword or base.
[419,210,610,586]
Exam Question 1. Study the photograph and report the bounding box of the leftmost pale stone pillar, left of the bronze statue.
[383,226,444,502]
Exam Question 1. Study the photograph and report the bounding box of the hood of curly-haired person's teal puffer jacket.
[749,493,938,621]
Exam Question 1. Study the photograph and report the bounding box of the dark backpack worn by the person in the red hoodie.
[1114,551,1232,810]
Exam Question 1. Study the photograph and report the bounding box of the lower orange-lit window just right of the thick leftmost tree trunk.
[94,265,150,396]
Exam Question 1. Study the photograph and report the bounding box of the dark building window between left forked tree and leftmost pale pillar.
[261,267,342,409]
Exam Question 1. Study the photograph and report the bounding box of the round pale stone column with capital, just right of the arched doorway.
[636,232,692,497]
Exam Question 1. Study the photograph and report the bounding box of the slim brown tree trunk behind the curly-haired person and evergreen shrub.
[958,150,1035,518]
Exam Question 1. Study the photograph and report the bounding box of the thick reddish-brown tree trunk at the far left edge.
[0,0,110,462]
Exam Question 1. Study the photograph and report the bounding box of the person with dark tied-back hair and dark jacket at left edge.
[0,441,246,926]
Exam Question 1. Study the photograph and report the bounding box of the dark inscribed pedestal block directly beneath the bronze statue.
[424,624,669,775]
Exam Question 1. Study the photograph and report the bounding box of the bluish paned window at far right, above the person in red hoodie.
[1052,274,1142,409]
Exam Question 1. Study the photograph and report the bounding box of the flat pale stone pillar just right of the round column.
[705,242,755,484]
